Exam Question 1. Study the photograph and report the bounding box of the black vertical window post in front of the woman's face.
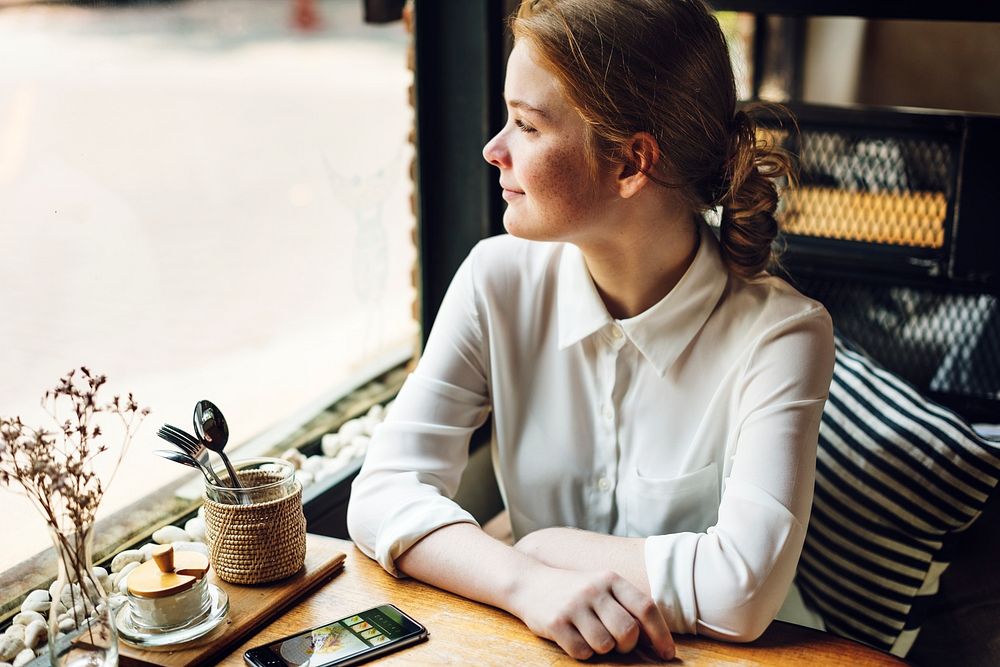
[415,0,505,343]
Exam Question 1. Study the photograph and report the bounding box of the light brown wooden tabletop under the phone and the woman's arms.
[207,535,905,667]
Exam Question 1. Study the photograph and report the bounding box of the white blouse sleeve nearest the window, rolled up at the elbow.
[347,253,489,576]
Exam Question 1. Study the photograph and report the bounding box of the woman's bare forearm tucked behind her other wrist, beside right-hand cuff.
[515,528,649,593]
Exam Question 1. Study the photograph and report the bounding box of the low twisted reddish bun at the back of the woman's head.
[719,110,793,278]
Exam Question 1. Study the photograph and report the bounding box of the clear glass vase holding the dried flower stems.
[49,525,118,667]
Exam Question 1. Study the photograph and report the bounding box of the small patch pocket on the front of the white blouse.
[625,463,719,537]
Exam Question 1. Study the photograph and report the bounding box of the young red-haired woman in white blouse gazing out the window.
[348,0,833,658]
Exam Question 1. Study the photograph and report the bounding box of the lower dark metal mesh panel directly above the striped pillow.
[798,278,1000,400]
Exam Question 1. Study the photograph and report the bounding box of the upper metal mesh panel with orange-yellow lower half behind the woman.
[780,130,954,248]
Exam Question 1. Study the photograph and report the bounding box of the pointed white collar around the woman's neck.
[556,224,729,376]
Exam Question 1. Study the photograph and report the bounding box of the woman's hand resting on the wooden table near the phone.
[509,563,674,660]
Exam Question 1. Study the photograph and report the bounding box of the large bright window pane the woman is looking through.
[0,0,417,570]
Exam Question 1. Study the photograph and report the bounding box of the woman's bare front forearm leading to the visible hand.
[396,523,541,614]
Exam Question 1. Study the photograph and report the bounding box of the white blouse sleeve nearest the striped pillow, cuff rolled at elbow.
[645,309,833,641]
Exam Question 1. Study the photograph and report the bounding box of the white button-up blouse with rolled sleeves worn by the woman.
[348,225,833,639]
